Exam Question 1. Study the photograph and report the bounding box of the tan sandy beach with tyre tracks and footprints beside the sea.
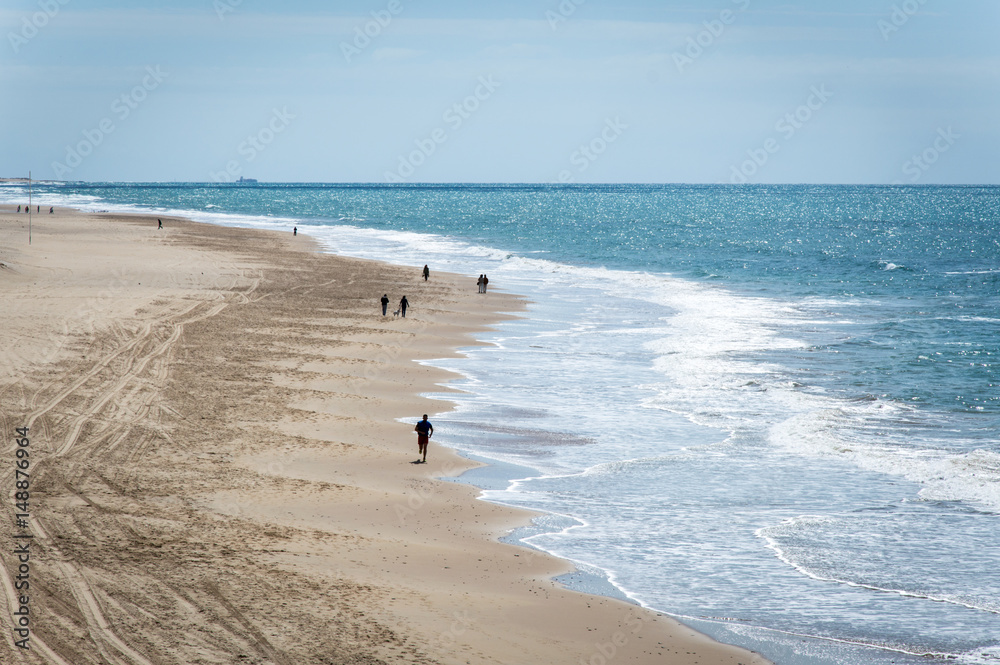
[0,206,766,665]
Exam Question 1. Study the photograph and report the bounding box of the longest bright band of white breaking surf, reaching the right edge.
[294,220,1000,509]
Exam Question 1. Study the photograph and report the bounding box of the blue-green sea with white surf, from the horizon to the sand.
[0,183,1000,665]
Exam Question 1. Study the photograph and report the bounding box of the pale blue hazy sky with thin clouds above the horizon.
[0,0,1000,184]
